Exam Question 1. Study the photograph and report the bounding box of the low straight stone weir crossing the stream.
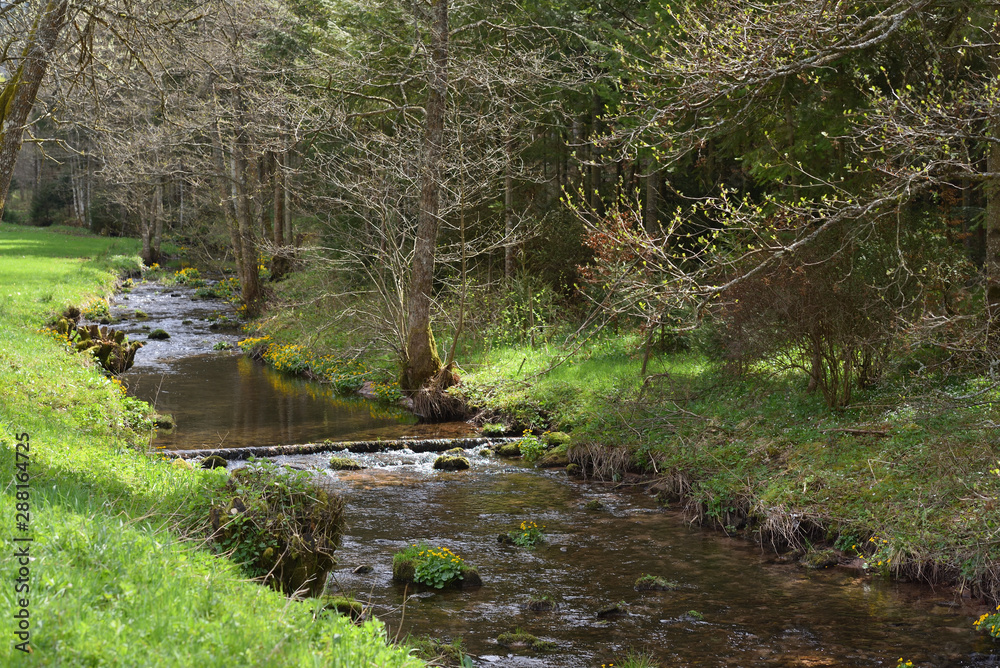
[160,436,519,459]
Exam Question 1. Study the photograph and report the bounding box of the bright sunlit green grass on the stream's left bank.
[0,224,423,666]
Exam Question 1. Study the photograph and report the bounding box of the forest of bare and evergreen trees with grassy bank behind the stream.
[0,0,1000,665]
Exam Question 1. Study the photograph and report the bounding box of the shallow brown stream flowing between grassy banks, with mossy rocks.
[112,283,1000,668]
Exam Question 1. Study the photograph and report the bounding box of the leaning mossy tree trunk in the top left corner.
[0,0,69,218]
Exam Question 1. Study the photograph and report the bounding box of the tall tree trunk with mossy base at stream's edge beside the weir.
[400,0,448,392]
